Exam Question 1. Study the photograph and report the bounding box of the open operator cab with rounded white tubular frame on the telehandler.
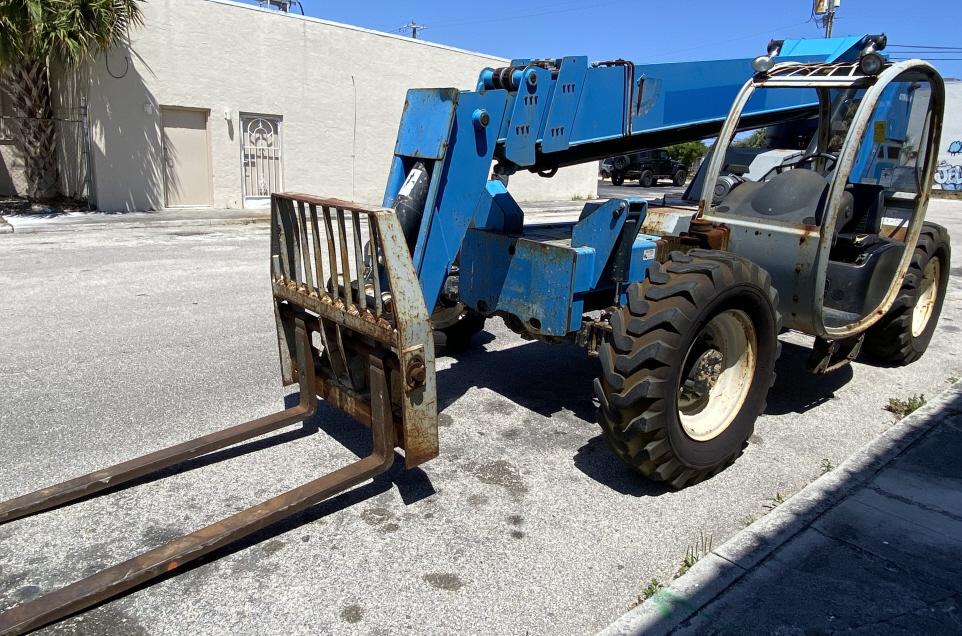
[701,57,943,337]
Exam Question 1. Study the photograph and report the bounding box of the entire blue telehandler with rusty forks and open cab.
[0,35,950,634]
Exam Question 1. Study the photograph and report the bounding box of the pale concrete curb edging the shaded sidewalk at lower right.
[599,382,962,636]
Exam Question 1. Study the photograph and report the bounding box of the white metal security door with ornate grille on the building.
[240,115,284,208]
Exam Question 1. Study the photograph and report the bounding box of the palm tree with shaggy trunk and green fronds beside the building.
[0,0,143,199]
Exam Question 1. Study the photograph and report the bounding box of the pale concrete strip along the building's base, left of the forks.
[0,208,270,234]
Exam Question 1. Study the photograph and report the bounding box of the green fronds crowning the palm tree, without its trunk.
[0,0,143,69]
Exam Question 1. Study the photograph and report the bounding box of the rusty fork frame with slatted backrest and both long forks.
[0,194,438,636]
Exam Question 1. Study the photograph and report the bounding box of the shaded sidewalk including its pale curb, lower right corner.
[602,382,962,636]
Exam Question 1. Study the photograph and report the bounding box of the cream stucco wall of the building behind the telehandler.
[88,0,597,210]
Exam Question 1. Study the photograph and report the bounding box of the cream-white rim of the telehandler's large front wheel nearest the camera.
[678,309,758,442]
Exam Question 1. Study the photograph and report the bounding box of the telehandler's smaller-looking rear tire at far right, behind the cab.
[862,223,952,366]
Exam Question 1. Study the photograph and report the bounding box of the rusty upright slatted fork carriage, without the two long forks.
[271,194,438,468]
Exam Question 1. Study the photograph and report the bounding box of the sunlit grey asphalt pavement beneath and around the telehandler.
[0,186,962,634]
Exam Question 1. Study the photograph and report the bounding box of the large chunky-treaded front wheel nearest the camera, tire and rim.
[595,250,781,488]
